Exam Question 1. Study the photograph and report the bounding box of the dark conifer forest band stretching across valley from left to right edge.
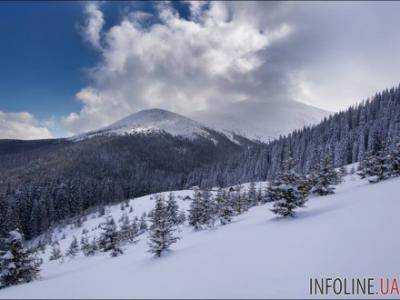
[0,87,400,239]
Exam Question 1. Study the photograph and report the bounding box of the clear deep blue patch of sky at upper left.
[0,2,91,118]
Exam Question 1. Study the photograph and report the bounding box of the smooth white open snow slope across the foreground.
[0,170,400,298]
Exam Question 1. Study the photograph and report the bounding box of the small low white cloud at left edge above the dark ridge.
[0,111,52,140]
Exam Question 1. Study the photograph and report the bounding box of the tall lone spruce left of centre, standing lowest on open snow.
[149,196,179,257]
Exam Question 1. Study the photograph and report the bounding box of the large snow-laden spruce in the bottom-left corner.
[0,229,40,287]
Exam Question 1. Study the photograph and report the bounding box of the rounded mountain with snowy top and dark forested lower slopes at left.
[0,110,257,238]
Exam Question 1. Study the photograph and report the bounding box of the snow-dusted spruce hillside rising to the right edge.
[188,86,400,186]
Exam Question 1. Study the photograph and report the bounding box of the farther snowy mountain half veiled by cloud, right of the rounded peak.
[189,99,329,142]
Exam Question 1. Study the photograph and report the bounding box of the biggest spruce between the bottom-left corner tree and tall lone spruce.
[99,216,123,256]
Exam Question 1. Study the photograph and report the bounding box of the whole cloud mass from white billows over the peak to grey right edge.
[62,1,400,134]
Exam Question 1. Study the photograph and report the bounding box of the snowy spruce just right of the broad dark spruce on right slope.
[311,154,340,196]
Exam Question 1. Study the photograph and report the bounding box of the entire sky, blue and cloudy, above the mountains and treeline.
[0,1,400,138]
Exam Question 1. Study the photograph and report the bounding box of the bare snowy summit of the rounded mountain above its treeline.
[74,109,248,143]
